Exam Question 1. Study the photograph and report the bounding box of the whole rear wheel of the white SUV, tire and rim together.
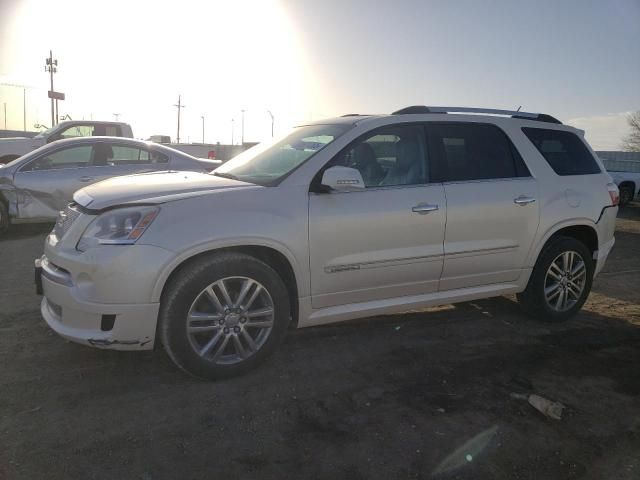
[517,237,594,322]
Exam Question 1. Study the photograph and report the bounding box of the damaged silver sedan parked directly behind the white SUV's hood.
[0,137,221,230]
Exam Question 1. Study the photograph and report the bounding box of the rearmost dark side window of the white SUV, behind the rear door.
[522,128,600,176]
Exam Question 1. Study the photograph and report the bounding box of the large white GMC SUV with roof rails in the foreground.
[36,107,618,378]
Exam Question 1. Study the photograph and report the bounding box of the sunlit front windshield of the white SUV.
[218,125,351,185]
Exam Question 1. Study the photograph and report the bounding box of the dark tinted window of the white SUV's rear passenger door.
[429,123,529,181]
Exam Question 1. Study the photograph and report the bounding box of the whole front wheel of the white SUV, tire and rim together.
[158,253,290,379]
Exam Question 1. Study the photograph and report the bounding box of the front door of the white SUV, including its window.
[309,125,446,308]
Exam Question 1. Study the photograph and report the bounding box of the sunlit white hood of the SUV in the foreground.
[73,172,263,210]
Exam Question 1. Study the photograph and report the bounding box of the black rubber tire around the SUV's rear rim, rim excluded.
[516,236,594,323]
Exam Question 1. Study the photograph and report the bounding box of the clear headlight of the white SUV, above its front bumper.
[76,207,160,252]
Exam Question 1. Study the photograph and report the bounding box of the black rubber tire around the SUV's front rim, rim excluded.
[158,252,291,380]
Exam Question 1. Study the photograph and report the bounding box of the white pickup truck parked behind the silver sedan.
[0,120,133,164]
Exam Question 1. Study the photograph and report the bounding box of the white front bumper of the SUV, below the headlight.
[36,229,174,350]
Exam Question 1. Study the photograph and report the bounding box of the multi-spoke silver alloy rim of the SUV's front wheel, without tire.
[187,277,274,365]
